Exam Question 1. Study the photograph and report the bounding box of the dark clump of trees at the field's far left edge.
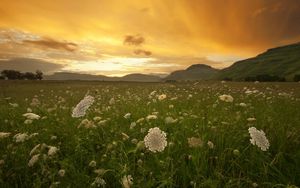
[0,70,43,80]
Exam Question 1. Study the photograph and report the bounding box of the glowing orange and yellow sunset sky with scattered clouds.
[0,0,300,76]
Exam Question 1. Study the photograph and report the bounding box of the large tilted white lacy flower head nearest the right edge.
[248,127,270,151]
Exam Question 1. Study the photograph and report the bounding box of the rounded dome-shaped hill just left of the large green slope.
[164,64,219,80]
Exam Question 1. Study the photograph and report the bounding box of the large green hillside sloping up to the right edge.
[217,43,300,81]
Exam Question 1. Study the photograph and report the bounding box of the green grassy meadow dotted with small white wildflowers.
[0,81,300,188]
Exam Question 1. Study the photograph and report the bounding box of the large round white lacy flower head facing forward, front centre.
[144,127,168,153]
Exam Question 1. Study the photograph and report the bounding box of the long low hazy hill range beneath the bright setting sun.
[44,72,161,82]
